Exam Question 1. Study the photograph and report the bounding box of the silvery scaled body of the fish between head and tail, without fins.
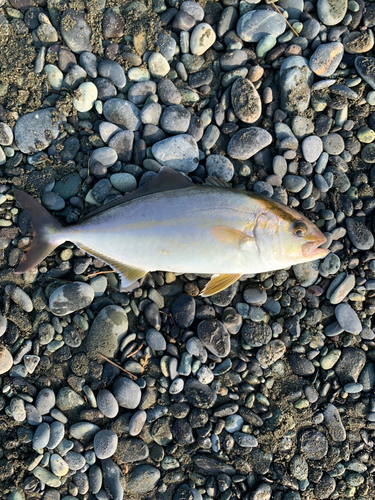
[67,188,269,274]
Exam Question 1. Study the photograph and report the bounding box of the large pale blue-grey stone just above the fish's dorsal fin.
[152,134,199,173]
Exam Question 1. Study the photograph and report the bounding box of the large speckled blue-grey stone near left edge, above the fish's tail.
[14,108,66,155]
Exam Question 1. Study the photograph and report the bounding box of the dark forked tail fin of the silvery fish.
[13,189,63,274]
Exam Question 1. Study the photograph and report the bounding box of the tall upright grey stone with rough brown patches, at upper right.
[280,56,314,114]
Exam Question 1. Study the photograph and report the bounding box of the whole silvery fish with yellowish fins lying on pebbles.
[14,167,329,297]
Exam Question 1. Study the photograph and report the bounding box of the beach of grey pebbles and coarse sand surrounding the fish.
[0,0,375,500]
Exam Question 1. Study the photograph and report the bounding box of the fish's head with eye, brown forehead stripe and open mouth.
[254,200,329,269]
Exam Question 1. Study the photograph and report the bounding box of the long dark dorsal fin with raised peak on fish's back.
[80,167,194,222]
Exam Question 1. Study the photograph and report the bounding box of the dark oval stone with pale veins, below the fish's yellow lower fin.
[197,319,230,358]
